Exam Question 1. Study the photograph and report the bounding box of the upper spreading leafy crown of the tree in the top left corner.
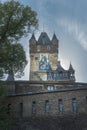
[0,0,38,44]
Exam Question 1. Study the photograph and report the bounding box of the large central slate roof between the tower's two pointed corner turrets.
[38,32,51,45]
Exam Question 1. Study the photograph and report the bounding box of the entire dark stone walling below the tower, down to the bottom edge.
[6,81,87,130]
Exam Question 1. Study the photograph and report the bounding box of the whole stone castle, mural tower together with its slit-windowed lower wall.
[6,32,87,117]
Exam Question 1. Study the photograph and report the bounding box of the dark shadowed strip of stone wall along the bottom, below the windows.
[9,114,87,130]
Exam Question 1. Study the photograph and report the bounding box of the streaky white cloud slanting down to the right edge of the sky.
[58,18,87,50]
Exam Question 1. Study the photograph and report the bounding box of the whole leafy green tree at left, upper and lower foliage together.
[0,0,38,77]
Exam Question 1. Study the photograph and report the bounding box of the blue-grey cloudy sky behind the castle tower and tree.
[1,0,87,82]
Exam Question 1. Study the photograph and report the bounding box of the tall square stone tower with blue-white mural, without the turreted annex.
[29,32,58,81]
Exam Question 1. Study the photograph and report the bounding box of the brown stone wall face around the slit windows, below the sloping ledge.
[7,90,87,117]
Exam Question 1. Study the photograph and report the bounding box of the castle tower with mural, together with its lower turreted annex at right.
[29,32,75,82]
